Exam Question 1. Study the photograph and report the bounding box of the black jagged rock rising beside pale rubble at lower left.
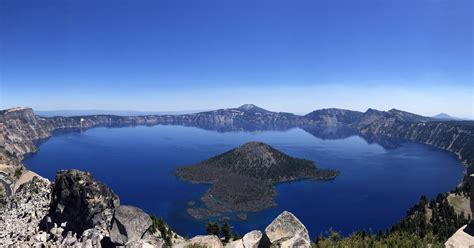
[44,170,119,235]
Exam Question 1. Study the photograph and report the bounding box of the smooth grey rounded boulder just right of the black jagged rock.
[110,206,152,245]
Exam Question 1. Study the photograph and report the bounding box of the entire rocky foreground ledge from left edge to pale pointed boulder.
[0,170,310,248]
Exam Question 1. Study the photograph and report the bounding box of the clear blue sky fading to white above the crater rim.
[0,0,474,118]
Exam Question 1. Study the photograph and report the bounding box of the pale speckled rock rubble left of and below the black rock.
[0,169,112,247]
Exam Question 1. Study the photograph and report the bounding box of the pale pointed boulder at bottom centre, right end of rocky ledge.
[265,211,311,247]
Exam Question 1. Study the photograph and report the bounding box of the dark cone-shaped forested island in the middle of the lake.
[176,142,338,218]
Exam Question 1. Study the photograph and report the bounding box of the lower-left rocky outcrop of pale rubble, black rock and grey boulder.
[0,170,169,247]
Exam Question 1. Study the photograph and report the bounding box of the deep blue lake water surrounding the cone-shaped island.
[24,125,464,239]
